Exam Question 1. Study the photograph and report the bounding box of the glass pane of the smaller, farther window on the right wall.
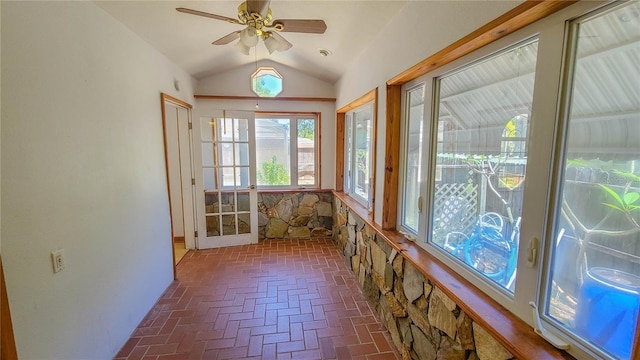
[353,106,373,201]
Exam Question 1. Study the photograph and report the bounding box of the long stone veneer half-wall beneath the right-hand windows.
[333,197,513,360]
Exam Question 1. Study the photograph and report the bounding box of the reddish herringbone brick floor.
[116,238,400,360]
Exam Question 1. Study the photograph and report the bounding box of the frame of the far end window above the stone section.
[255,112,321,191]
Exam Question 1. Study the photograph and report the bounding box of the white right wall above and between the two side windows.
[336,0,522,223]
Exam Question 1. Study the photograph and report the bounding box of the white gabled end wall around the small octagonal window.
[193,60,336,189]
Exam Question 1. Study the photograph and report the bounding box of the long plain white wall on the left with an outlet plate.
[1,1,193,359]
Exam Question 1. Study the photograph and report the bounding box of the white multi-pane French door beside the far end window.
[193,110,258,249]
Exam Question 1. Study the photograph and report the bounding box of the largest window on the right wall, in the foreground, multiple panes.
[398,2,640,359]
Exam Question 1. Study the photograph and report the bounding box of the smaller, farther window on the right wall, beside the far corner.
[345,103,375,208]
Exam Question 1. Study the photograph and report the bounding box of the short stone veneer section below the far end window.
[258,191,333,239]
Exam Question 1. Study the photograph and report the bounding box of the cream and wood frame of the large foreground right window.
[392,2,639,357]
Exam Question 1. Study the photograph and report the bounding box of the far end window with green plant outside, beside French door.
[256,114,319,188]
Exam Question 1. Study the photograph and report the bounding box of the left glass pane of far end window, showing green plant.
[256,119,291,186]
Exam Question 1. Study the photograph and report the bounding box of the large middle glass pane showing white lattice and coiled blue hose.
[431,40,538,292]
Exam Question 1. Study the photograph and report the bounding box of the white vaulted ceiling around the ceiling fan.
[96,0,406,83]
